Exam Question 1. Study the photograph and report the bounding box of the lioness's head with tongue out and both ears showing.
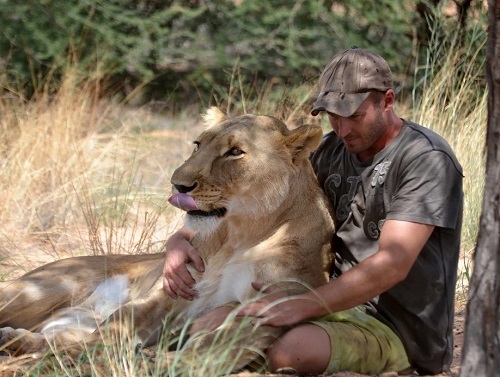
[169,108,322,232]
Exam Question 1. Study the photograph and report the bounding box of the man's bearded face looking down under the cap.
[328,97,387,160]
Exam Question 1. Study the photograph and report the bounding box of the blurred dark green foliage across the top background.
[0,0,484,101]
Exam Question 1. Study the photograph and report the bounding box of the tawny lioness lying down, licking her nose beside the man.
[0,108,334,368]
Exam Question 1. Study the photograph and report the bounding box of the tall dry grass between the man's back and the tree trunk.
[409,30,488,304]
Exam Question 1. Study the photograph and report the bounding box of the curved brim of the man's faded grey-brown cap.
[311,92,370,118]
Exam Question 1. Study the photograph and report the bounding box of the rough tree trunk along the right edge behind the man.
[460,0,500,377]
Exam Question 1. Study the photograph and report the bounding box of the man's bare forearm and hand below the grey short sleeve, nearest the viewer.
[240,220,434,326]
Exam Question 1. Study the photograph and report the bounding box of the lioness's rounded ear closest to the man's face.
[286,125,323,165]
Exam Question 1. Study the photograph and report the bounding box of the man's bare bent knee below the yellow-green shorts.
[267,323,331,374]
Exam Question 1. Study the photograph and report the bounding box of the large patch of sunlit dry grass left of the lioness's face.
[0,75,203,277]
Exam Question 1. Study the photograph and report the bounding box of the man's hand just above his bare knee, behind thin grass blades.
[238,283,318,327]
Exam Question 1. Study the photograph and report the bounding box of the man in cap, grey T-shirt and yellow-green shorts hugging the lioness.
[164,48,463,374]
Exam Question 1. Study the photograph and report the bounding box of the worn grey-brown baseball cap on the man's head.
[311,47,393,117]
